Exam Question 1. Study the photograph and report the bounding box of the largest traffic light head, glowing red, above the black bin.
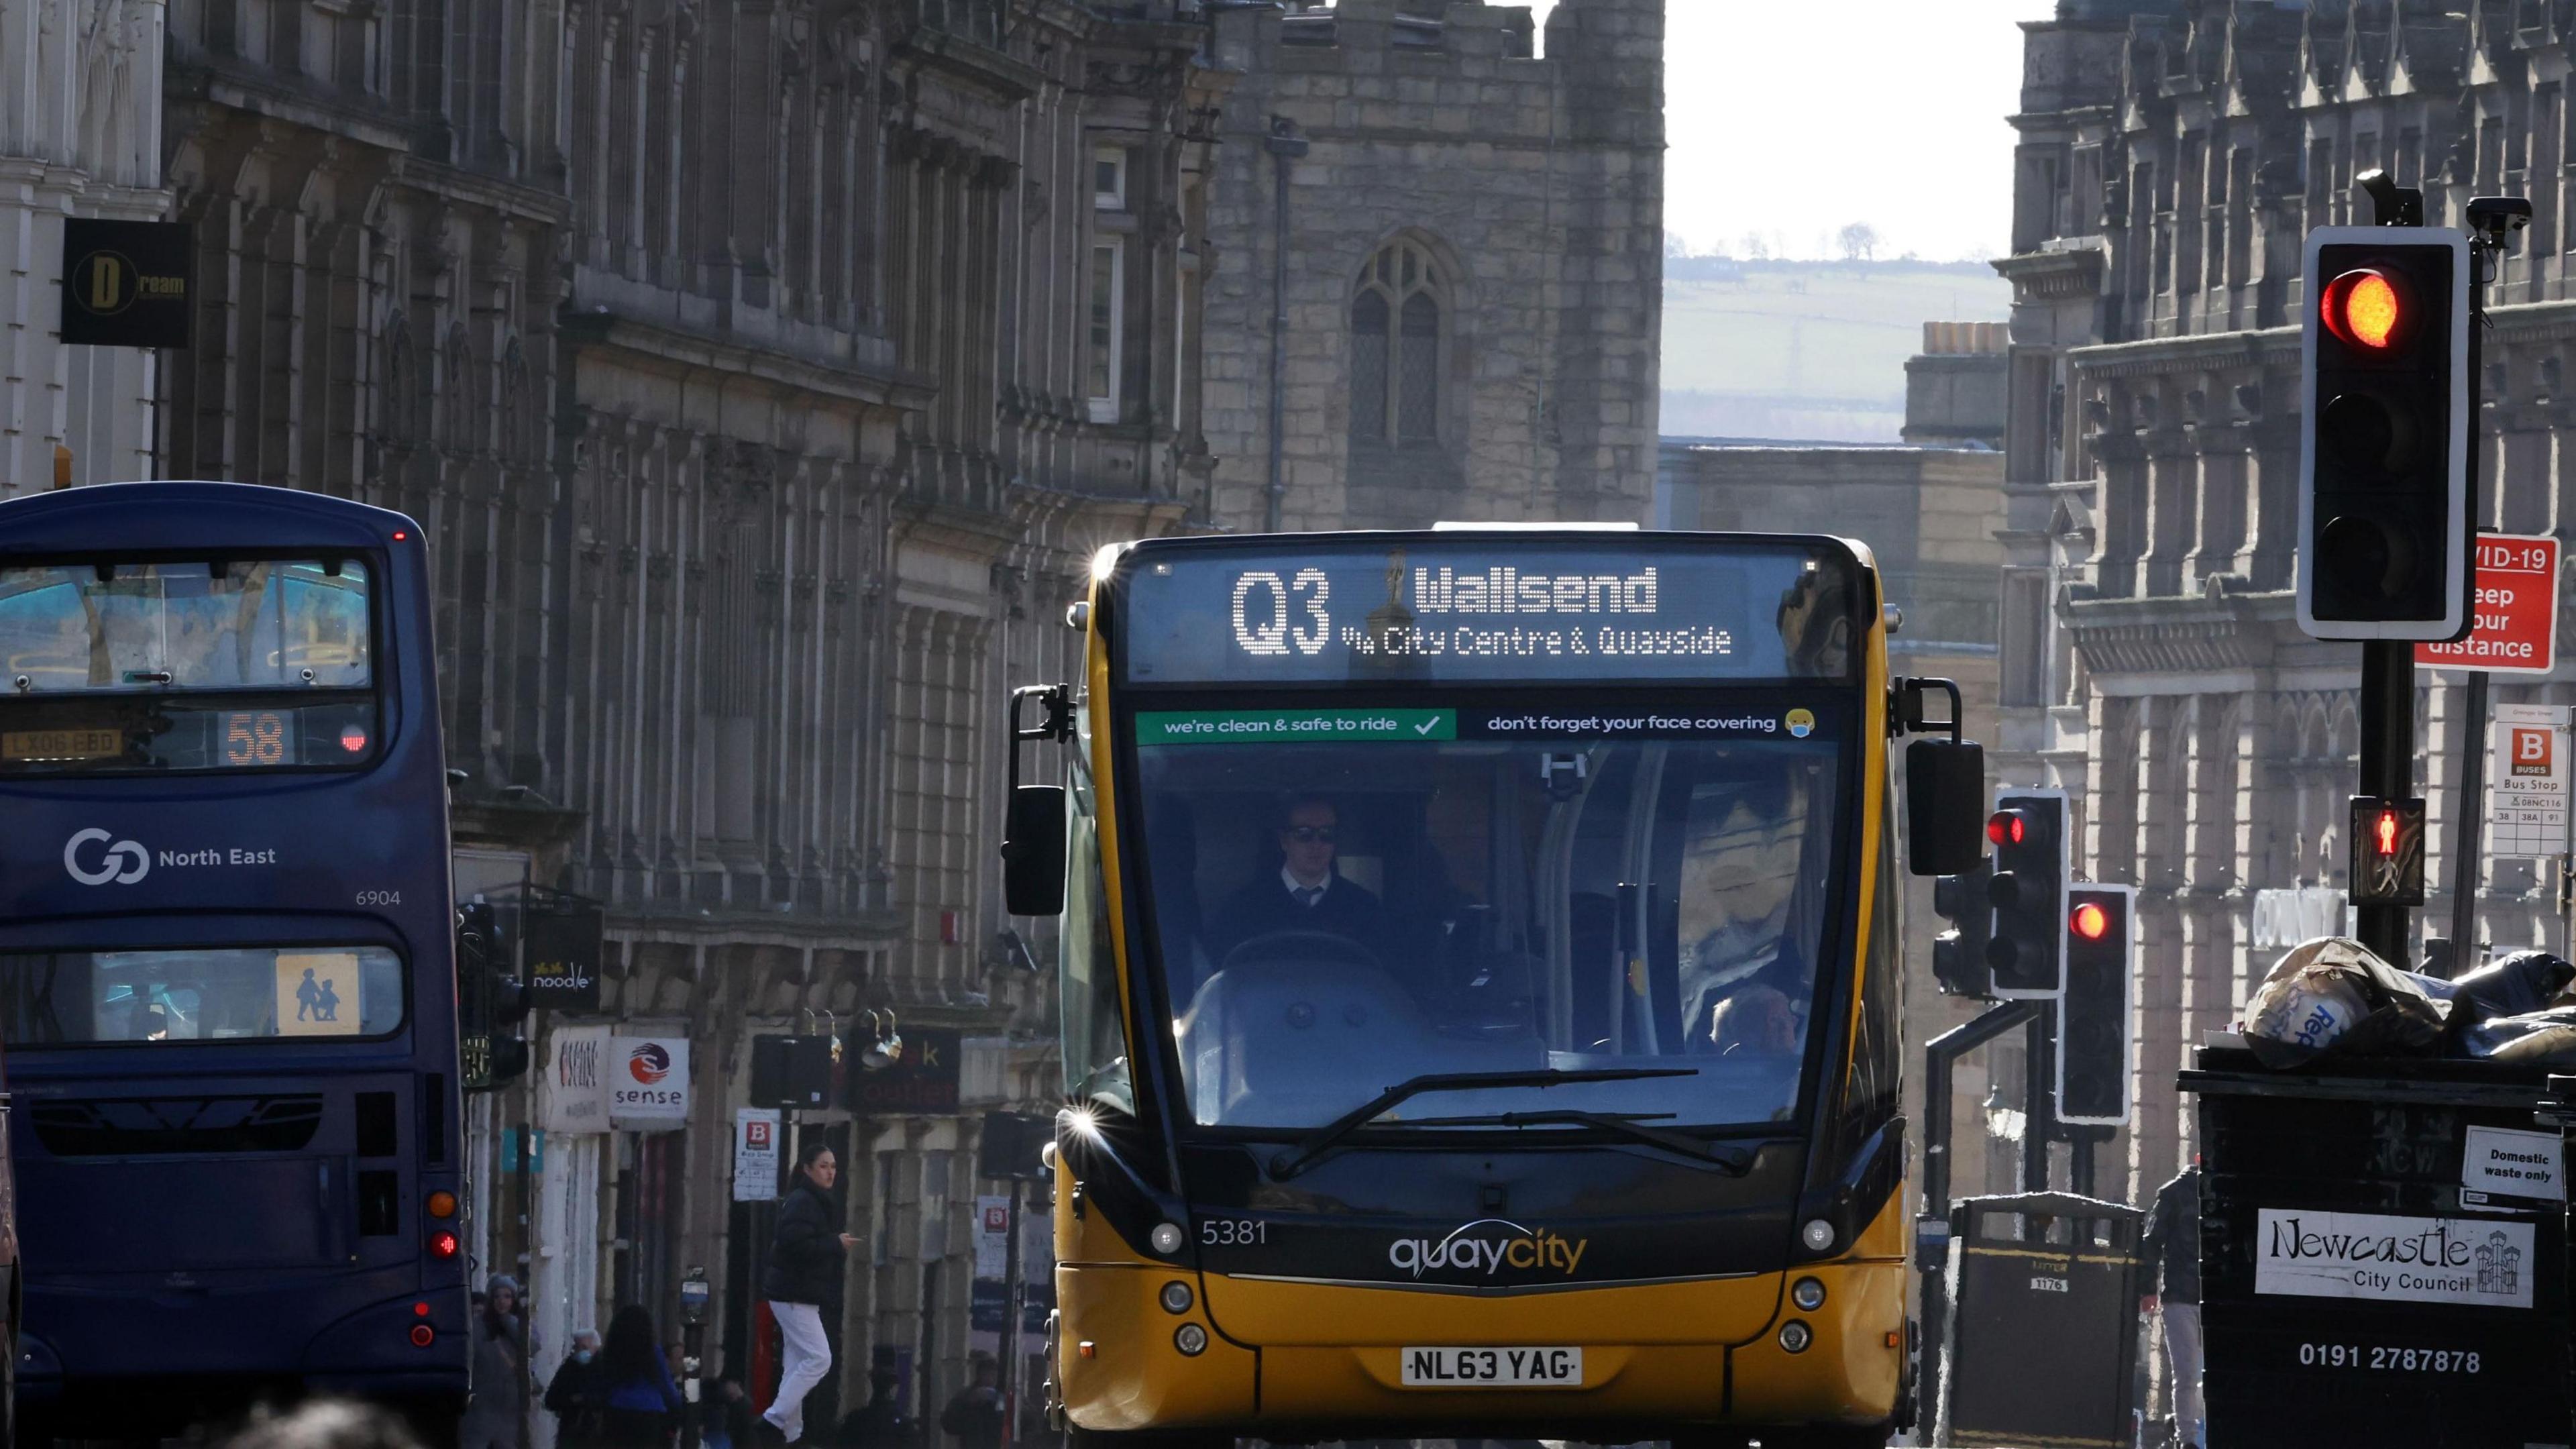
[2298,227,2475,639]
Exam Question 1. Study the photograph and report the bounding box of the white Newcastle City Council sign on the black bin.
[2254,1207,2540,1307]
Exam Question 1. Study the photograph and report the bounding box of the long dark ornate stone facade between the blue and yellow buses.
[134,0,1232,1439]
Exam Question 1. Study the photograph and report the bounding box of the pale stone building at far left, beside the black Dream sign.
[0,0,170,495]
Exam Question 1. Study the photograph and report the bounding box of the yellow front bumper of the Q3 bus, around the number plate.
[1054,1260,1909,1439]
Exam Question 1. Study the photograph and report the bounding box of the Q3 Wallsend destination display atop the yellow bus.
[1126,539,1858,684]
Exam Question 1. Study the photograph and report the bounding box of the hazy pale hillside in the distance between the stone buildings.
[1662,258,2012,443]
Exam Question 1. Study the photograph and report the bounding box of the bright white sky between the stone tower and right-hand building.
[1533,0,2055,260]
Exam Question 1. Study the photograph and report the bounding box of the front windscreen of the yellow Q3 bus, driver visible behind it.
[1134,706,1849,1129]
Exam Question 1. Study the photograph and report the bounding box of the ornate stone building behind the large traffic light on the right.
[1994,0,2576,1199]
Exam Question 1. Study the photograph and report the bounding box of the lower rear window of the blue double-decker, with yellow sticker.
[0,947,402,1046]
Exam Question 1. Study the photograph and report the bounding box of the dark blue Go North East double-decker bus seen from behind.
[0,482,469,1439]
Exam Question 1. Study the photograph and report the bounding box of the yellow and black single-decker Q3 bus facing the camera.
[1002,529,1984,1449]
